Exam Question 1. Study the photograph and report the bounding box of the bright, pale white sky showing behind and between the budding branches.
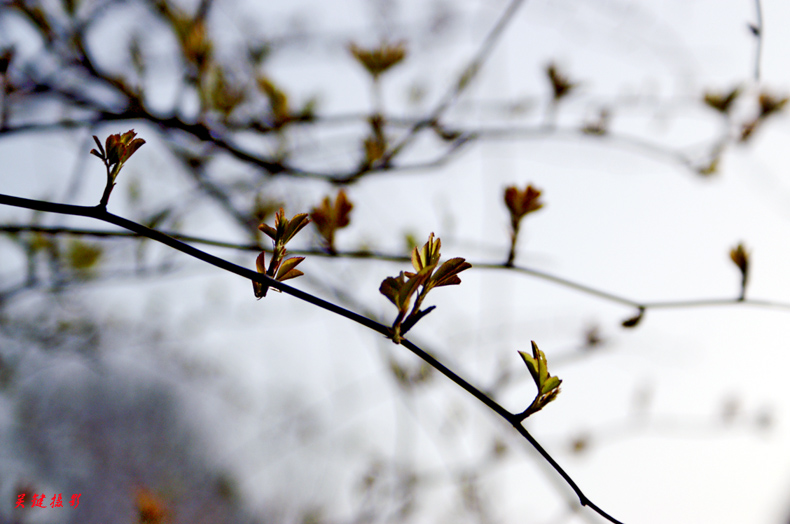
[0,0,790,524]
